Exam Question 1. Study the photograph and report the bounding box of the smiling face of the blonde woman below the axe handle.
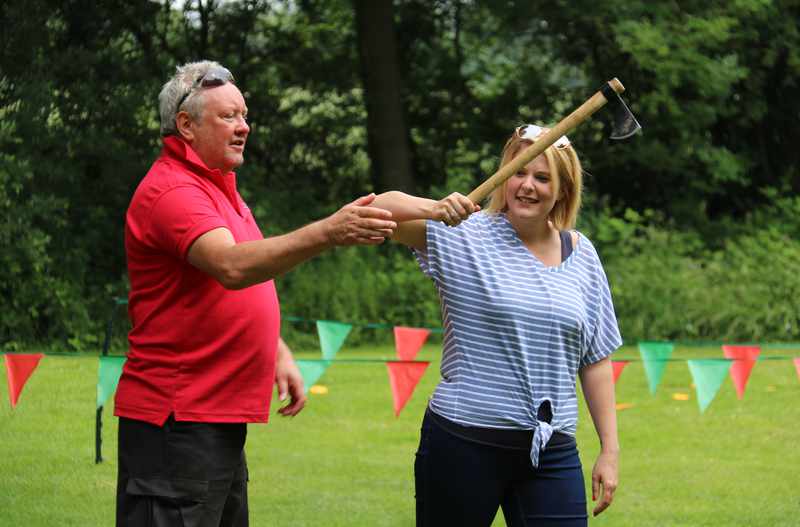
[505,154,557,221]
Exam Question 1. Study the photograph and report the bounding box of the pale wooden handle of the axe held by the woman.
[467,77,625,203]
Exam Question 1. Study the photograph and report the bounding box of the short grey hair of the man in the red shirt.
[158,60,228,137]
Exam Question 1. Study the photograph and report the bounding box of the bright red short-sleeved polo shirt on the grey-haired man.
[115,137,280,426]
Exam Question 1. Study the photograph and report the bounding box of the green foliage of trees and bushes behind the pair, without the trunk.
[0,0,800,350]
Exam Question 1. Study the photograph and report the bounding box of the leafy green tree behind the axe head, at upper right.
[532,0,800,226]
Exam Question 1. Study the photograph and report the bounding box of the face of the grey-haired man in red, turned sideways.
[184,82,250,174]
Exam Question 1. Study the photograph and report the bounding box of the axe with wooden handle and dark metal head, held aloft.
[467,77,642,203]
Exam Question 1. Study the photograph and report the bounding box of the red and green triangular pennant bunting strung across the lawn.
[3,297,800,462]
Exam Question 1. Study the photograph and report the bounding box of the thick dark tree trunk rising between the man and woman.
[353,0,415,192]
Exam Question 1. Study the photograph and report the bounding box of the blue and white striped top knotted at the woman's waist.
[416,212,622,466]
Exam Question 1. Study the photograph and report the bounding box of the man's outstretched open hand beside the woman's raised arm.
[322,194,397,245]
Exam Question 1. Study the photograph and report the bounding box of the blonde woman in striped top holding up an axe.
[373,125,621,527]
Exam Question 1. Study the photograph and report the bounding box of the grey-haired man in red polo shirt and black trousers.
[115,61,396,527]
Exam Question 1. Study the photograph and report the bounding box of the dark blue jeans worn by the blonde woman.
[414,414,587,527]
